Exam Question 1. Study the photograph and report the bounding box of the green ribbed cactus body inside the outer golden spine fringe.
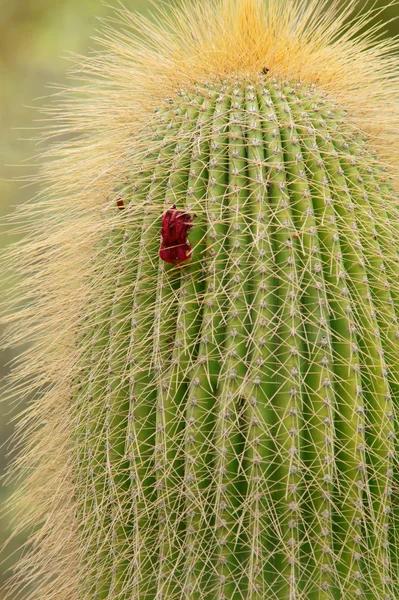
[72,75,399,600]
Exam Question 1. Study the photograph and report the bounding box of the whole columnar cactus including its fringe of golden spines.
[2,0,399,600]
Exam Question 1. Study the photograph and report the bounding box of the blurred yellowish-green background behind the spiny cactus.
[0,0,399,600]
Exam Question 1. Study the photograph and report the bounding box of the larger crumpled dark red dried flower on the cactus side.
[159,204,195,265]
